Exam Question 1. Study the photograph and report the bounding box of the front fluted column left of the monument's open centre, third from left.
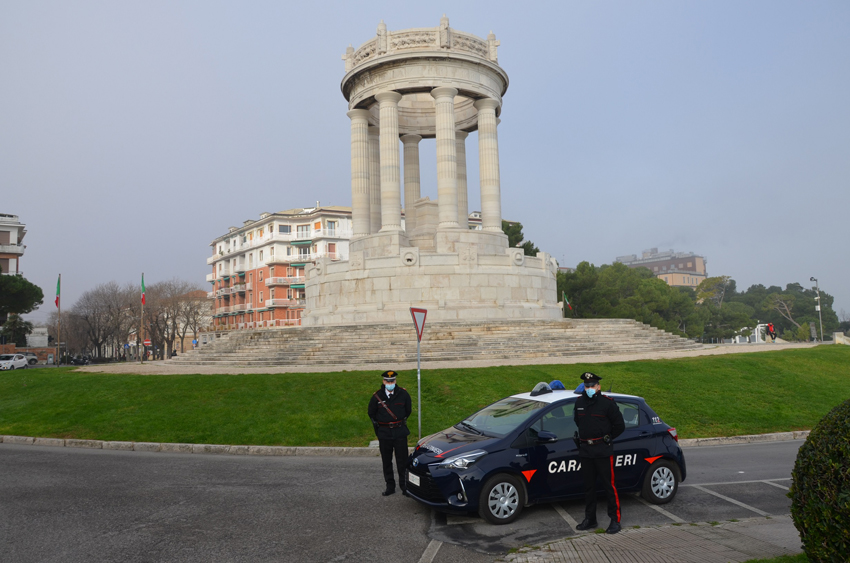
[375,92,401,233]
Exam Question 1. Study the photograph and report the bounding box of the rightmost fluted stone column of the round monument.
[475,98,502,232]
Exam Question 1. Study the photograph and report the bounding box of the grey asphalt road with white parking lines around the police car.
[0,440,802,563]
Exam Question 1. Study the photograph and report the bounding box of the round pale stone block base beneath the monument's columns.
[301,237,563,326]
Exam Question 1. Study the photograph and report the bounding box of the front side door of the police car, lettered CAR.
[516,402,582,500]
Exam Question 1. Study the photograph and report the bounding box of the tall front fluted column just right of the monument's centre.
[431,88,458,229]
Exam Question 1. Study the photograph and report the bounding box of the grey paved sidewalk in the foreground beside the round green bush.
[504,515,803,563]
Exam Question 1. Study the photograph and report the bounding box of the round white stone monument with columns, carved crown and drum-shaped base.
[302,16,562,326]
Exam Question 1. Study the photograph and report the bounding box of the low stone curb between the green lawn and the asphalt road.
[0,430,809,457]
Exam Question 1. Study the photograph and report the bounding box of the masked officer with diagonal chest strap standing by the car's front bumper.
[369,370,412,496]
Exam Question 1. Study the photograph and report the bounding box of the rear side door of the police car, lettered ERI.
[613,399,654,487]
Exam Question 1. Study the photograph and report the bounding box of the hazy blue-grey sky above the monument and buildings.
[0,0,850,321]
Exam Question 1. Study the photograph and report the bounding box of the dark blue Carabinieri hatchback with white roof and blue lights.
[407,382,686,524]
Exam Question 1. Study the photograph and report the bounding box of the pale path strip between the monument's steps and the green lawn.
[77,343,818,375]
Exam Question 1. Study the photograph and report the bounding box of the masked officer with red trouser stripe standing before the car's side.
[573,371,626,534]
